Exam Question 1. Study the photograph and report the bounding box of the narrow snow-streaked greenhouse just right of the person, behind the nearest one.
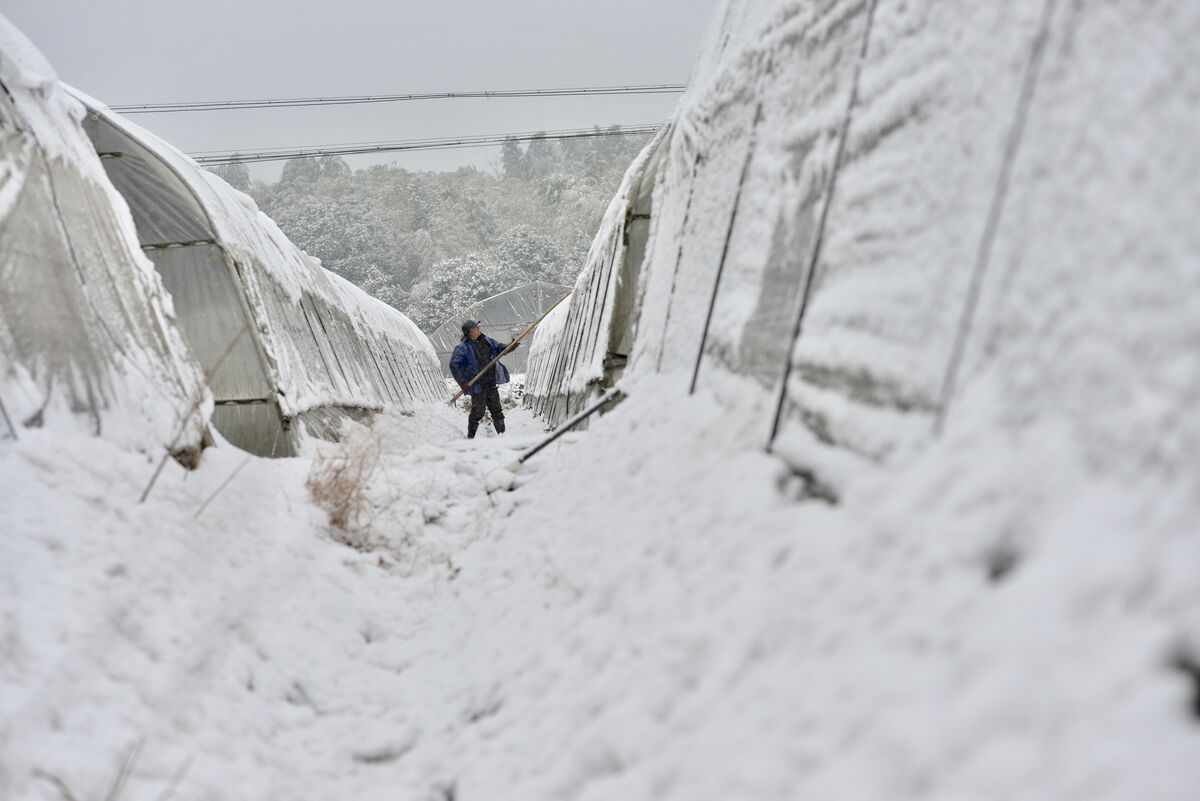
[524,126,671,426]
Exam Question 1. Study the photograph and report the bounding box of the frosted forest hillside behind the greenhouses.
[212,128,648,332]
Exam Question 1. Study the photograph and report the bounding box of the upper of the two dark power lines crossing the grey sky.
[119,84,688,114]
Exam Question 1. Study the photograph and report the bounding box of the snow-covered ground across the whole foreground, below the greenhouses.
[0,375,1200,801]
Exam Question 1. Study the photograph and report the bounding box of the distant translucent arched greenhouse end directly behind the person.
[430,281,570,377]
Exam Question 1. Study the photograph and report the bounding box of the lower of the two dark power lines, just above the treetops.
[190,124,660,167]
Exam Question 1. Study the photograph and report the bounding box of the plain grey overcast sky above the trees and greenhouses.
[0,0,718,179]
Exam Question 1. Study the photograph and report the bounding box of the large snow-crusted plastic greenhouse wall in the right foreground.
[609,0,1200,482]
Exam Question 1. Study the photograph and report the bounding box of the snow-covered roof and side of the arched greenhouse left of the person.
[71,90,442,417]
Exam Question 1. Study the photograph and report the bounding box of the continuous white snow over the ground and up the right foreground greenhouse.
[0,0,1200,801]
